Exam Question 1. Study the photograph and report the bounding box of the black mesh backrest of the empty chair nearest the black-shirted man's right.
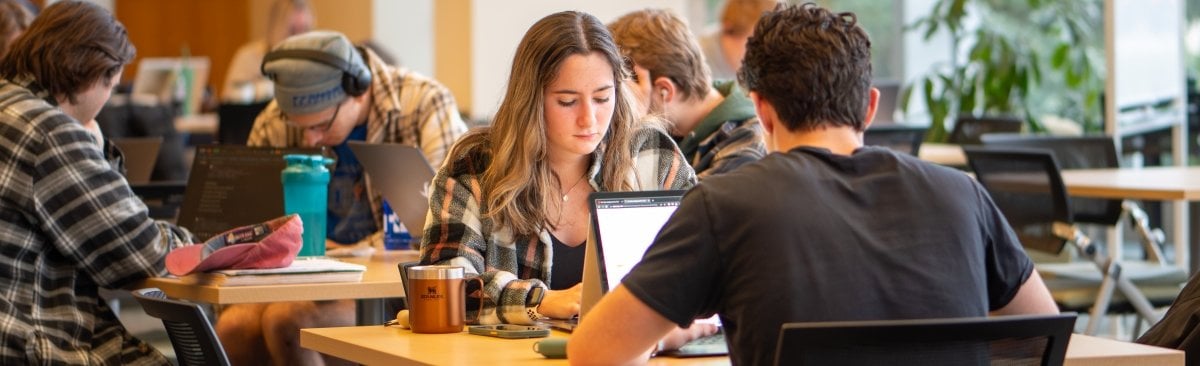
[962,146,1074,254]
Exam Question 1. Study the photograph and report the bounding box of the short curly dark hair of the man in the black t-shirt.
[738,2,871,132]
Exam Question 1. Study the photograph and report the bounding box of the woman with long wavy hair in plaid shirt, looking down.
[421,11,696,324]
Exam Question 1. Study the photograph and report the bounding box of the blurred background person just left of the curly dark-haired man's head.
[700,0,779,80]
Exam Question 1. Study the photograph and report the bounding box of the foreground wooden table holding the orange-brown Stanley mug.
[300,326,1183,366]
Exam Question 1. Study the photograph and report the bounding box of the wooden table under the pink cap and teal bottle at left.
[140,251,420,324]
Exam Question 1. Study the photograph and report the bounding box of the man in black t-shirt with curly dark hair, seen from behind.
[568,4,1058,365]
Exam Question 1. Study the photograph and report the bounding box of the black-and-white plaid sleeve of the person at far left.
[31,115,192,288]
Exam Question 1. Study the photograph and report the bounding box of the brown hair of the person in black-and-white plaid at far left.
[0,0,136,103]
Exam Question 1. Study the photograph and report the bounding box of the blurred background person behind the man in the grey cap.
[221,0,316,104]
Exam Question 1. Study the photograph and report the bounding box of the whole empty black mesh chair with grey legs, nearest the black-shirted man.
[964,146,1181,334]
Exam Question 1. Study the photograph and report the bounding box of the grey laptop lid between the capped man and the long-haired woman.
[348,142,433,241]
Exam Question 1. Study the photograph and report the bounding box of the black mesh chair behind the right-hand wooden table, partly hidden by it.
[982,133,1165,264]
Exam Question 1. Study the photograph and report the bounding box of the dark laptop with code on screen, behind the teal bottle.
[176,145,322,240]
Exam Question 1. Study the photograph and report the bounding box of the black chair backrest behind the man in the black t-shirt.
[775,313,1075,365]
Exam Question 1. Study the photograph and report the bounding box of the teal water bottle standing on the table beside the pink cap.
[280,154,334,257]
